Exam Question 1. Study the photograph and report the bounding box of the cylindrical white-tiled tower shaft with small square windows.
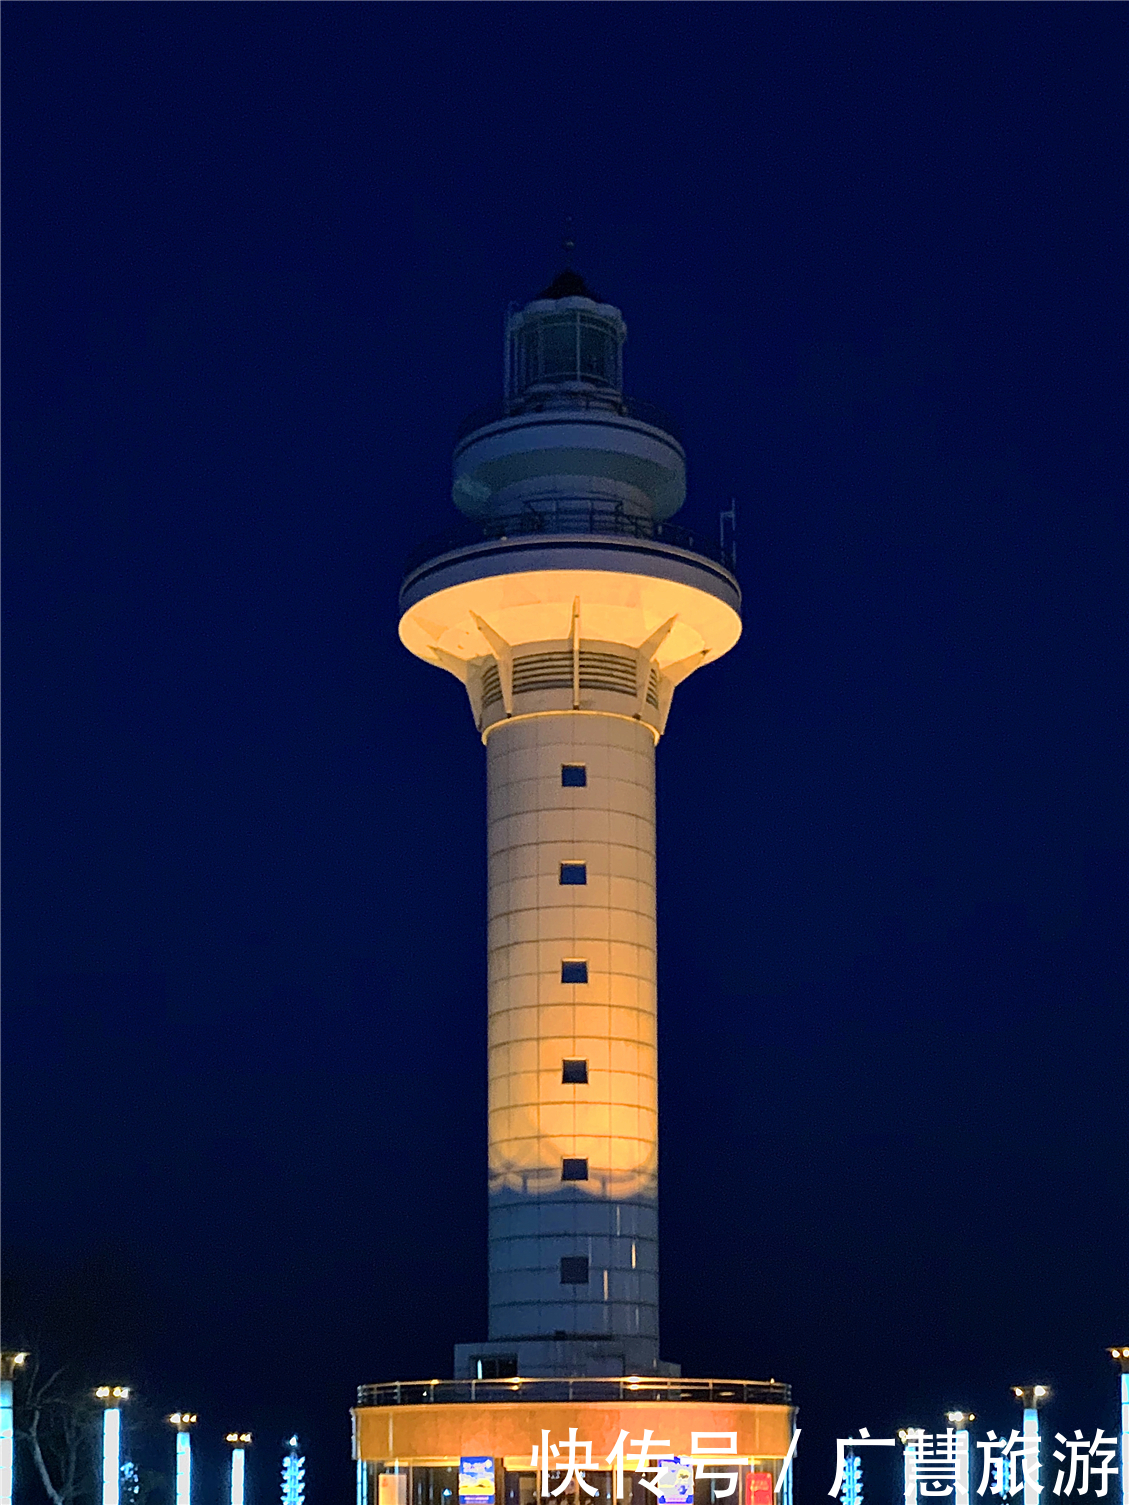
[486,713,658,1339]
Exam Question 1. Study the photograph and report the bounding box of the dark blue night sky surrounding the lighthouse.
[3,3,1129,1505]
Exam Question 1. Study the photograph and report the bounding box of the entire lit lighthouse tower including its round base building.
[354,271,793,1505]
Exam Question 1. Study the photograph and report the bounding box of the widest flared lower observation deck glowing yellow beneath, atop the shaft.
[400,497,741,739]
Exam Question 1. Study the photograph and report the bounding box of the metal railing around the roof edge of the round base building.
[357,1376,792,1406]
